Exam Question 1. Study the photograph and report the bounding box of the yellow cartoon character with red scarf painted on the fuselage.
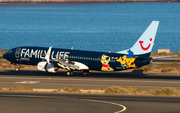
[101,54,114,71]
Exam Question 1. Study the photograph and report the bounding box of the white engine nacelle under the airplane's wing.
[37,61,58,73]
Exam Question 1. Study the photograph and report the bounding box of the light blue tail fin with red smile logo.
[117,21,159,55]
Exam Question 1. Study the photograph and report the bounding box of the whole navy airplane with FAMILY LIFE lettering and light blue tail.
[3,21,172,75]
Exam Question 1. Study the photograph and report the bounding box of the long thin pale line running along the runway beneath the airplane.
[0,77,180,84]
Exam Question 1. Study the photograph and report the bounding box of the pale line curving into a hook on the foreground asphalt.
[1,95,126,113]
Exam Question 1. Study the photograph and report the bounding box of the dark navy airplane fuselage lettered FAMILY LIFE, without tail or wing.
[3,47,152,71]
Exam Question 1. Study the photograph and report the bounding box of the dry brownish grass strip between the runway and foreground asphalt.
[0,85,180,96]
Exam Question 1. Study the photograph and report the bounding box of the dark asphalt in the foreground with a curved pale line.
[0,92,180,113]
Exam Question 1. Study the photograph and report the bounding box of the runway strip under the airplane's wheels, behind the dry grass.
[0,70,180,90]
